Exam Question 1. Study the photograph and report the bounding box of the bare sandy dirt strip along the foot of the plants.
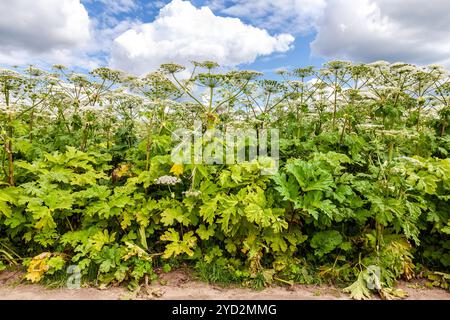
[0,271,450,300]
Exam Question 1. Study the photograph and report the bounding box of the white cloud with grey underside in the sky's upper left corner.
[0,0,91,64]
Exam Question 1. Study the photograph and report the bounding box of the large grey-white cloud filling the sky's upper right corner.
[311,0,450,66]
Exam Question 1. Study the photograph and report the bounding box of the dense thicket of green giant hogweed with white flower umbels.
[0,61,450,299]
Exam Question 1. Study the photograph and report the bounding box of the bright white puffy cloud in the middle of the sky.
[110,0,294,74]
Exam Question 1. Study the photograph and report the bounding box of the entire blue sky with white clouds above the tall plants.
[0,0,450,76]
